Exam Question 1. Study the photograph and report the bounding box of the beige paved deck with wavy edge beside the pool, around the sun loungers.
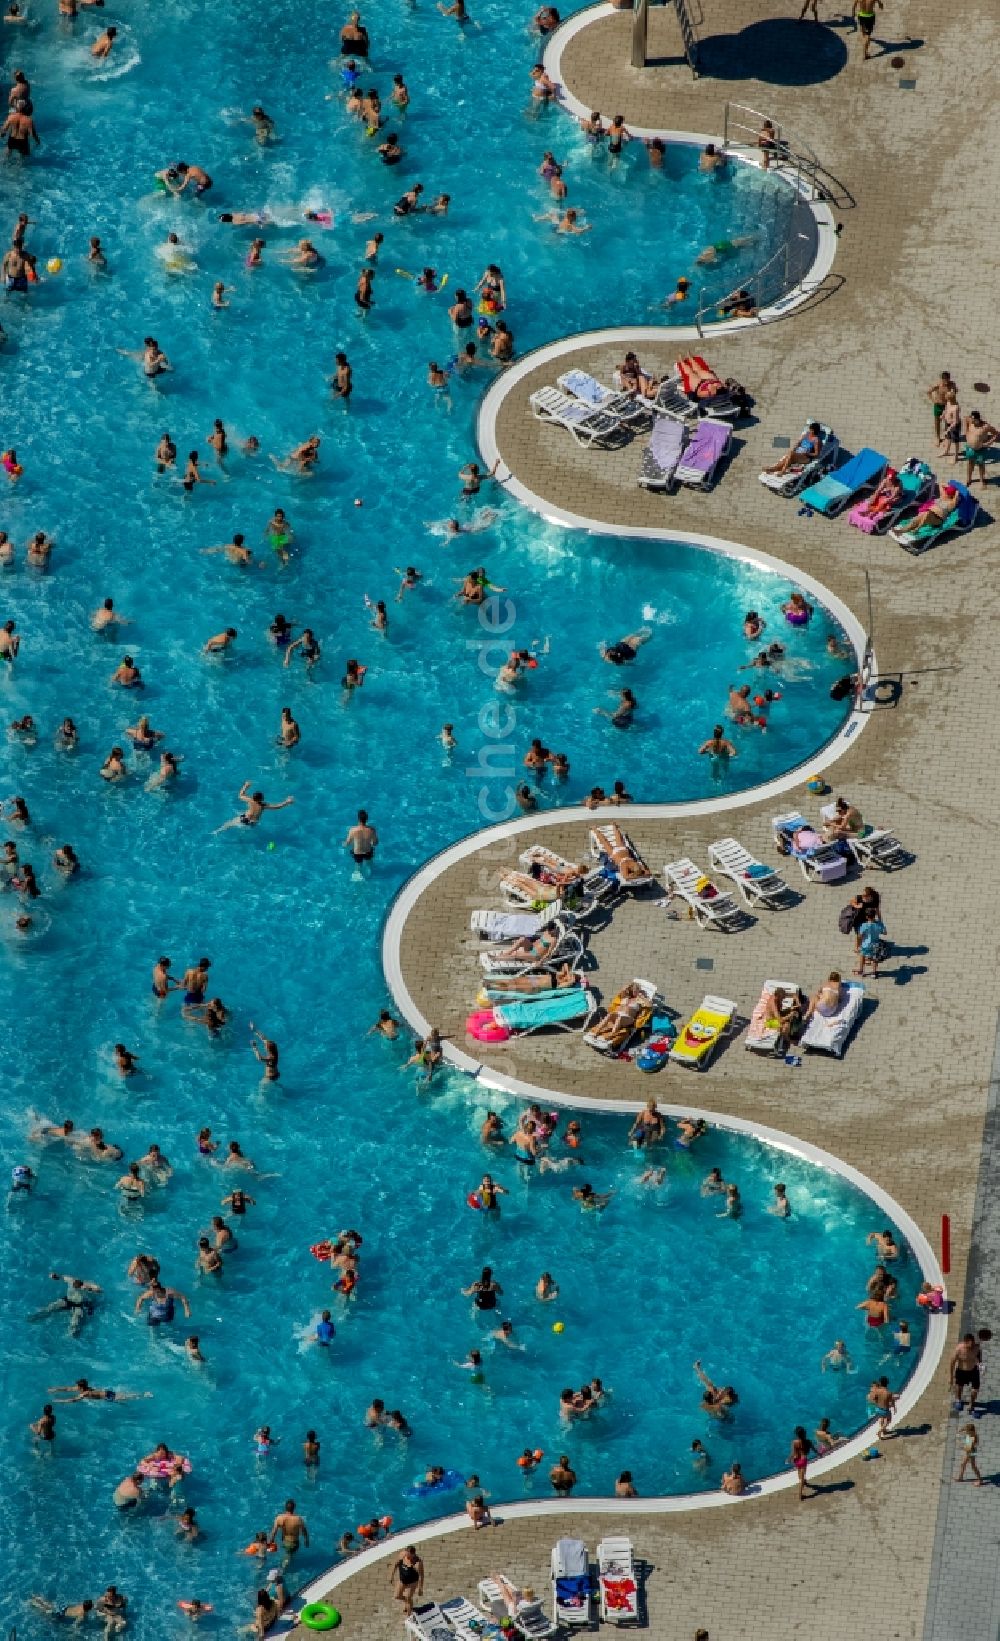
[288,0,1000,1641]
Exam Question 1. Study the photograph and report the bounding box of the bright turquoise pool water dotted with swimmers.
[0,3,866,1641]
